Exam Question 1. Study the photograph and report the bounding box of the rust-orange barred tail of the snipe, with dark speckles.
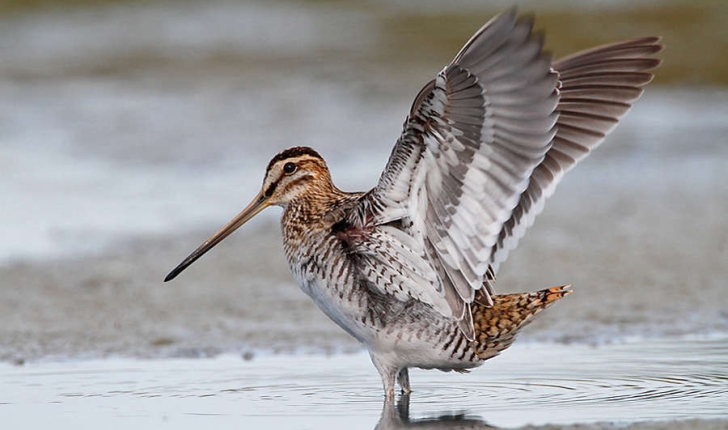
[472,285,571,360]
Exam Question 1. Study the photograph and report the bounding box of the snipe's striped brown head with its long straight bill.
[164,146,335,282]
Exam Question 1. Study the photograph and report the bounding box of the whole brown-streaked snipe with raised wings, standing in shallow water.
[165,9,662,399]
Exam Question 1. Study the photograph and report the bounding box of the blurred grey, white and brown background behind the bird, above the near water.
[0,0,728,363]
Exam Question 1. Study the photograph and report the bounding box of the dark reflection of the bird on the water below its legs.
[374,394,497,430]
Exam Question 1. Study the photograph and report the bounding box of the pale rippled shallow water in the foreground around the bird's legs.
[0,337,728,429]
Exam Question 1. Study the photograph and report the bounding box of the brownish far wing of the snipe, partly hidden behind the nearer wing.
[491,37,662,273]
